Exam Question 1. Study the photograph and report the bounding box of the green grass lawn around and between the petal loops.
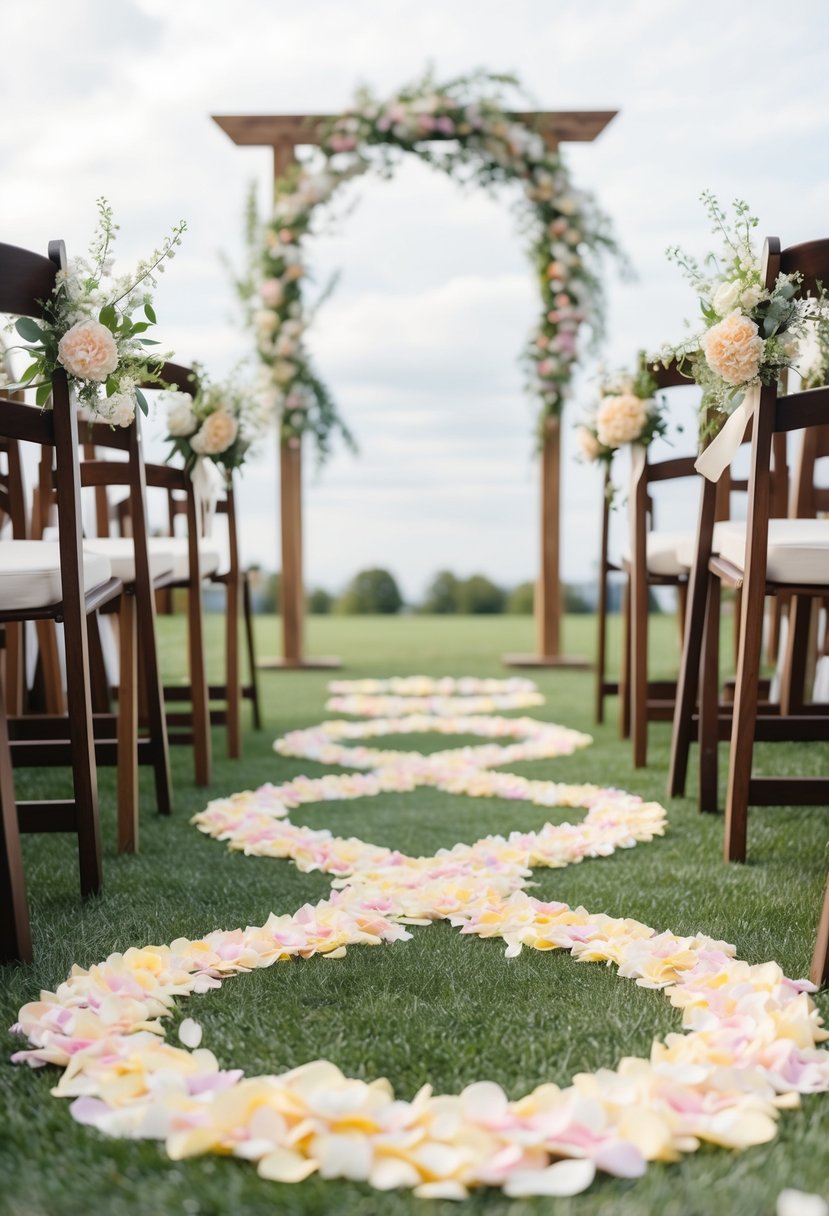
[0,617,829,1216]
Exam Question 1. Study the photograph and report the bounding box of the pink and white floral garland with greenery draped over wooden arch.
[238,73,615,457]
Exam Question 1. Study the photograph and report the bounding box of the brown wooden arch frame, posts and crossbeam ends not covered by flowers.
[212,109,616,668]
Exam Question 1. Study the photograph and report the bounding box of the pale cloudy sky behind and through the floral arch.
[0,0,829,597]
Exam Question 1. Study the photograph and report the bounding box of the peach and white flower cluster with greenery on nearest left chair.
[16,198,187,427]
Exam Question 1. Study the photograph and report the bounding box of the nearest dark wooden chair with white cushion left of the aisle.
[0,241,120,961]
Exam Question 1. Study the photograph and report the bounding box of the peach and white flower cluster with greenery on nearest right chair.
[662,191,829,424]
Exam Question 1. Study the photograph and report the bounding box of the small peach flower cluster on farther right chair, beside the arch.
[576,356,667,465]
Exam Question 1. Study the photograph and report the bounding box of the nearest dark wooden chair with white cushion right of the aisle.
[700,238,829,861]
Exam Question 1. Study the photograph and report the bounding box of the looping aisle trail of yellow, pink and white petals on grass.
[15,689,829,1199]
